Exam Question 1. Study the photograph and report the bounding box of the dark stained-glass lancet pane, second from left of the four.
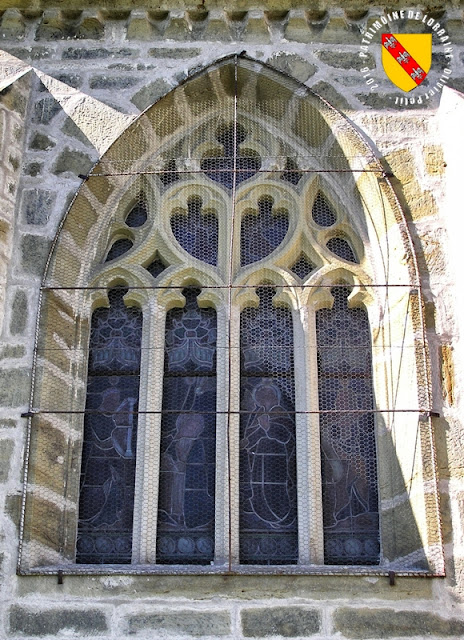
[157,289,216,564]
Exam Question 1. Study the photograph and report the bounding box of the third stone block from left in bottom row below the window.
[241,606,321,638]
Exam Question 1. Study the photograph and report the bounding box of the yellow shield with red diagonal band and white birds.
[382,33,432,91]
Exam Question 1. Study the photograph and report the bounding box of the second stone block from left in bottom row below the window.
[128,611,230,638]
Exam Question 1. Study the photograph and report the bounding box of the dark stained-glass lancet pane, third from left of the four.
[239,288,298,565]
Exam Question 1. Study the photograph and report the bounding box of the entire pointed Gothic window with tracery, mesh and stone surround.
[20,56,443,574]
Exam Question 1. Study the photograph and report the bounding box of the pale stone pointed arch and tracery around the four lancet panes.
[20,56,442,572]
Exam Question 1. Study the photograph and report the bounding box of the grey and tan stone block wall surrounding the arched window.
[0,2,464,640]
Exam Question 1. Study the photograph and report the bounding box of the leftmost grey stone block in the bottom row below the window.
[9,606,108,636]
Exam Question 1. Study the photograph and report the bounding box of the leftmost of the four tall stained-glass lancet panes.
[76,287,142,564]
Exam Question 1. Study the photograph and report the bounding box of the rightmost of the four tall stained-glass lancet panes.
[316,287,380,565]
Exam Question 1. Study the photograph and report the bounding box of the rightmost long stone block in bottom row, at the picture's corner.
[334,608,464,640]
